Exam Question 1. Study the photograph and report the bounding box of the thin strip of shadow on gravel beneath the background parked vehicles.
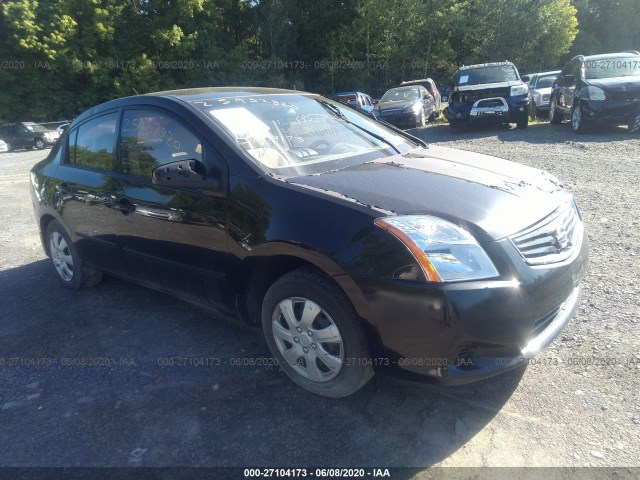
[407,122,640,145]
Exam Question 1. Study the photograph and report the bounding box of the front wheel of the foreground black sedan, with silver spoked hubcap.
[262,267,373,398]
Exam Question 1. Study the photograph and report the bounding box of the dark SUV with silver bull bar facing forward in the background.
[444,62,529,131]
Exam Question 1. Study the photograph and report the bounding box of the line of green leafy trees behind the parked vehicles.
[0,0,640,122]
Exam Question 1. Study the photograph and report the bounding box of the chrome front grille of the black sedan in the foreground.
[511,202,583,265]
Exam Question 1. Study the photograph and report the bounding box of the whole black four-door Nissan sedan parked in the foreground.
[31,87,588,397]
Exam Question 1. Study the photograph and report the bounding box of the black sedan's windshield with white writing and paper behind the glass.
[192,94,418,177]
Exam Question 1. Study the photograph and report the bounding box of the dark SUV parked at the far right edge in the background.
[549,51,640,133]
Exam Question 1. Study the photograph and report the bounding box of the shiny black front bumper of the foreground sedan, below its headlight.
[358,226,589,385]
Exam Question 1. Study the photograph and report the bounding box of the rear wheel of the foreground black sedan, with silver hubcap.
[45,220,102,290]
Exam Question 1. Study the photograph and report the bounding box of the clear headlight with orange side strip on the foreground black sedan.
[375,215,499,282]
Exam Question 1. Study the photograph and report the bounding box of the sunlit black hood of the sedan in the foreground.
[287,146,570,241]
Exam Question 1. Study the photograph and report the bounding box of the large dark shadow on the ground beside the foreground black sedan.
[0,260,524,470]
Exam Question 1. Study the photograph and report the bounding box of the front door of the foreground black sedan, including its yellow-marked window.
[114,109,235,311]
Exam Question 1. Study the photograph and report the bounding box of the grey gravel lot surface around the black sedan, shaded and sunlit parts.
[0,124,640,478]
